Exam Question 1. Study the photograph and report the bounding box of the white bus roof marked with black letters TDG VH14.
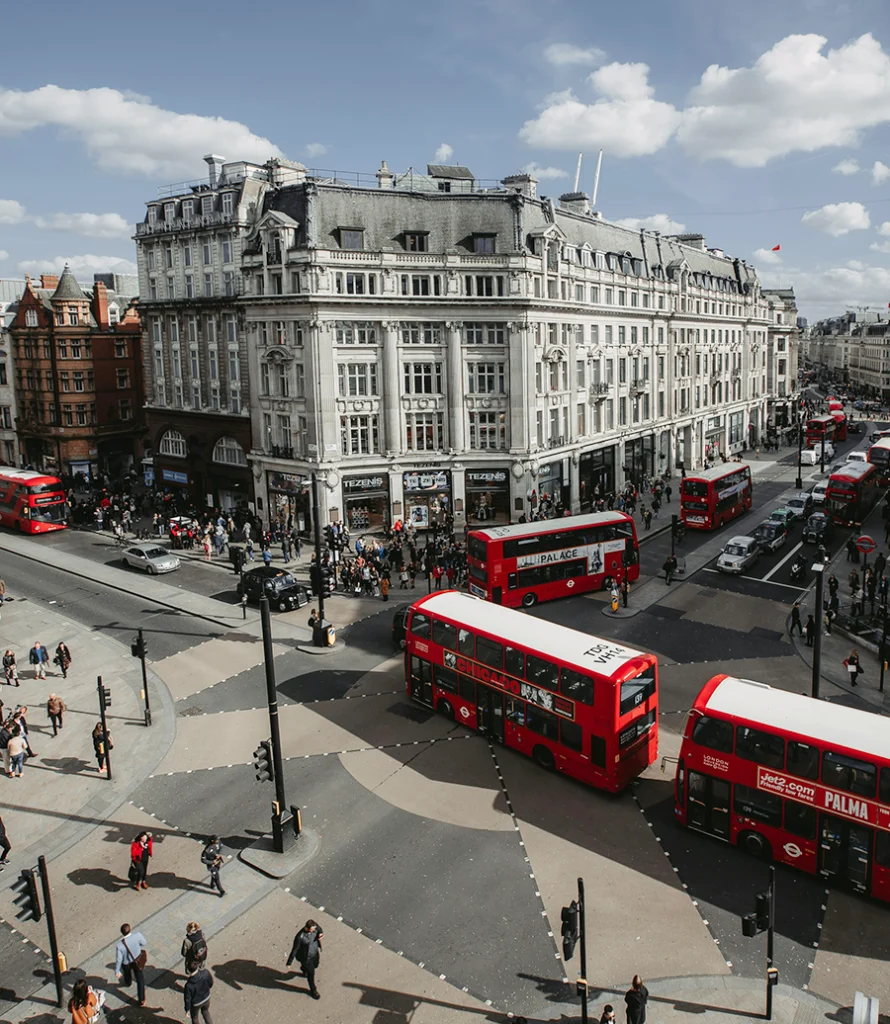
[417,590,646,676]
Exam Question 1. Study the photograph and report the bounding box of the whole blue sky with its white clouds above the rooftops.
[0,0,890,318]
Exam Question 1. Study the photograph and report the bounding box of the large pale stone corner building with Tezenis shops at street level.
[137,161,789,531]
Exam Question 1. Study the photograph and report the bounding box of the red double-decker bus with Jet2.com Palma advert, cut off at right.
[674,676,890,900]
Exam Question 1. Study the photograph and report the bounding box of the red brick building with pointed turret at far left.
[9,267,144,479]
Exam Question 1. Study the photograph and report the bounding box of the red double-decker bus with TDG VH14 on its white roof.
[405,590,659,793]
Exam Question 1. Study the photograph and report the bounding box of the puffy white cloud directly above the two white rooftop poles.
[519,63,680,157]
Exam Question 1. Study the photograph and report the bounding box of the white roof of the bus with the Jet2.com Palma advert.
[707,677,890,759]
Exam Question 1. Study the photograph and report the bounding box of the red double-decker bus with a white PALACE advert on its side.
[467,512,640,608]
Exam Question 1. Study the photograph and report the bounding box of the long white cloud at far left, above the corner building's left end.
[0,85,284,177]
